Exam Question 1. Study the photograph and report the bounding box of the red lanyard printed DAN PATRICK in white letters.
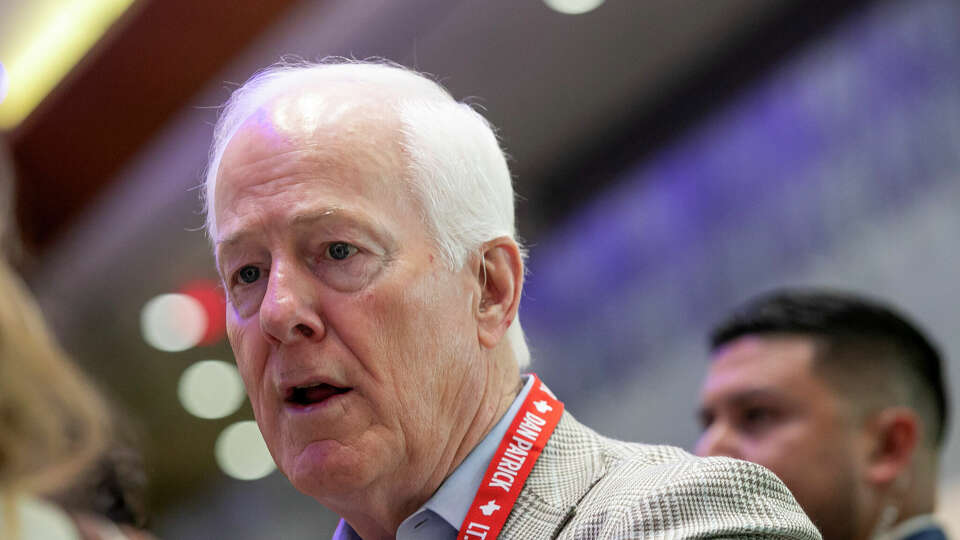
[457,374,563,540]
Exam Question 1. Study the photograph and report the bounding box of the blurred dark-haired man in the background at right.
[697,290,947,540]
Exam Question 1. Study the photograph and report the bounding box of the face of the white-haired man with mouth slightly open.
[213,95,492,505]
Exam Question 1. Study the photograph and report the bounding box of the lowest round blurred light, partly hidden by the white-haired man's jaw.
[214,420,277,480]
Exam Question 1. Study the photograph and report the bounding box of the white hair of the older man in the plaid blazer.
[201,58,530,367]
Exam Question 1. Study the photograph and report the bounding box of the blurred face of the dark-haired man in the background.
[696,335,864,538]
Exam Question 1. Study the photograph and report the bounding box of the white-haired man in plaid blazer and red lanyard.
[205,63,817,540]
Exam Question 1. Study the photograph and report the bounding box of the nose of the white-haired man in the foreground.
[260,261,326,344]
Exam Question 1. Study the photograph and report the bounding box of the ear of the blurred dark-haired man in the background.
[867,407,920,487]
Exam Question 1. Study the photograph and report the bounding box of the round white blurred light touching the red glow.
[140,294,207,352]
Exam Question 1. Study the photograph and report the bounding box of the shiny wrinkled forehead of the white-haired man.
[211,86,410,251]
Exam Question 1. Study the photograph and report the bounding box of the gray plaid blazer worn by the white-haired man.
[499,412,820,540]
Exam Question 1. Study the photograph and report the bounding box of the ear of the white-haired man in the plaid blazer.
[476,236,523,349]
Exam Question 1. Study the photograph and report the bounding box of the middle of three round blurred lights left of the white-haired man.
[177,360,244,419]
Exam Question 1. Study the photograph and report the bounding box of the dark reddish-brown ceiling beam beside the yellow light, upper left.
[5,0,293,249]
